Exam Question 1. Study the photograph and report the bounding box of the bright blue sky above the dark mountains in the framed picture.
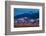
[14,8,39,16]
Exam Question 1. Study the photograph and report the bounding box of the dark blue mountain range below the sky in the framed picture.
[14,12,39,19]
